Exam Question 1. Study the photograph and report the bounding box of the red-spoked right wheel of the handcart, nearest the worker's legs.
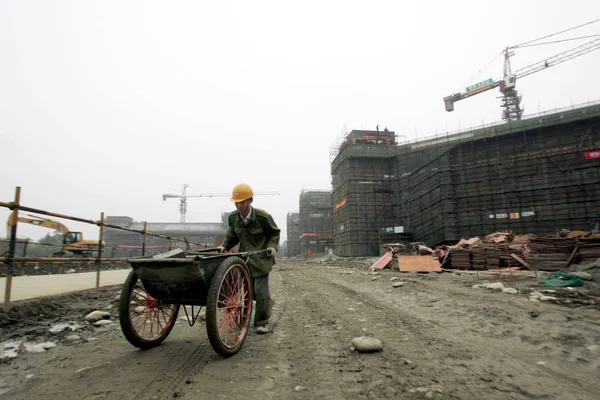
[206,257,252,357]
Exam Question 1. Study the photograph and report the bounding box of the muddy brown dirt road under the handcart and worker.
[0,260,600,400]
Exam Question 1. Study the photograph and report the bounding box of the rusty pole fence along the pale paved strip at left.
[0,186,212,312]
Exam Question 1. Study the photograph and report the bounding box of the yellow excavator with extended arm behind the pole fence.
[6,214,104,257]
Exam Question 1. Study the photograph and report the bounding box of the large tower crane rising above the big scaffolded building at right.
[444,20,600,121]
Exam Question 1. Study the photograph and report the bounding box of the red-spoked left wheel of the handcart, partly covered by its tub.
[119,270,179,349]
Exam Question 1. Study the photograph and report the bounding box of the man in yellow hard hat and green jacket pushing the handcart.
[221,183,280,334]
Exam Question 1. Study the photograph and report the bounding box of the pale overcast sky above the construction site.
[0,0,600,241]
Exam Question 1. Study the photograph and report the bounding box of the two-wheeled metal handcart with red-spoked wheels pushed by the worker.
[119,248,267,357]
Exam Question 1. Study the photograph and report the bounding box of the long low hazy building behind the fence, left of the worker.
[104,213,229,257]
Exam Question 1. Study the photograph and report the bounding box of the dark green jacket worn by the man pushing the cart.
[221,207,280,277]
